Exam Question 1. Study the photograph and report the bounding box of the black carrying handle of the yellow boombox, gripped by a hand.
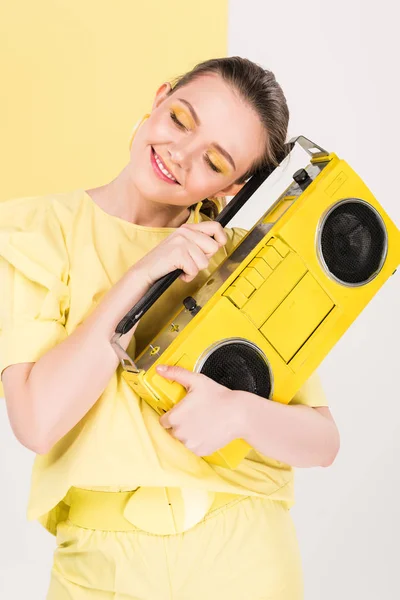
[113,136,328,339]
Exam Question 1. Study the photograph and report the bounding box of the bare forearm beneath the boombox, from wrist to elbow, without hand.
[234,391,340,467]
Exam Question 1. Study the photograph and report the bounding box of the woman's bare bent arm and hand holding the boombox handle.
[2,221,227,454]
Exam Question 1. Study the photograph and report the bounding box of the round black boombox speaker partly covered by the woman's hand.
[199,340,272,398]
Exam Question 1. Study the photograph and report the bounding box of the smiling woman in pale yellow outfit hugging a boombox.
[0,57,339,600]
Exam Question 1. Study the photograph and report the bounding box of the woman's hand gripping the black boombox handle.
[134,221,228,286]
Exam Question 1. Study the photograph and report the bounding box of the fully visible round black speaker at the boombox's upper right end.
[319,198,387,285]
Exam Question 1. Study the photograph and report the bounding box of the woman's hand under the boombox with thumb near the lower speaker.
[157,366,242,456]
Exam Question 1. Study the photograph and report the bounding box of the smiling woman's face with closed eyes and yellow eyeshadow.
[130,74,266,207]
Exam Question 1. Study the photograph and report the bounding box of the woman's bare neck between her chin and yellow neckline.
[88,166,190,227]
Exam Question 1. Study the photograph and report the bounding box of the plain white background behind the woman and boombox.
[0,0,400,600]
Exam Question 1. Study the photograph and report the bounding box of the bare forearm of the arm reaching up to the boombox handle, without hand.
[25,264,150,454]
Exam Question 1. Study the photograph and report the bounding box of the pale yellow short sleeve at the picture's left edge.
[0,198,69,382]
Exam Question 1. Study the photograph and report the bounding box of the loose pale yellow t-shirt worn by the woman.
[0,189,327,534]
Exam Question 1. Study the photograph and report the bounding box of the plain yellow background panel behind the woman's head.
[0,0,228,396]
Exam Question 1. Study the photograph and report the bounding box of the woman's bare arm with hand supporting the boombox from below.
[157,365,339,467]
